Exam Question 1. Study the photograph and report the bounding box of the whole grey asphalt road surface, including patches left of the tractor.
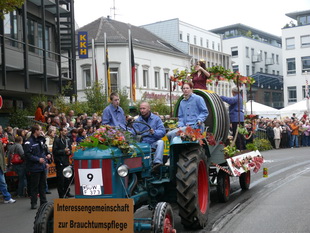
[0,147,310,233]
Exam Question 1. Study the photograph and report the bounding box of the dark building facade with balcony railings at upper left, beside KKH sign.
[0,0,76,122]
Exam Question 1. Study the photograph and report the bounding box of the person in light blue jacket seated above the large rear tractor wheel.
[167,82,209,142]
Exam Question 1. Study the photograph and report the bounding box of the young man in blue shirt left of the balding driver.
[101,92,126,130]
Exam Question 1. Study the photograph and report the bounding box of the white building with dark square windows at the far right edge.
[282,10,310,106]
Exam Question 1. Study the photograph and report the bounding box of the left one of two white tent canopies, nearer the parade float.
[245,100,280,118]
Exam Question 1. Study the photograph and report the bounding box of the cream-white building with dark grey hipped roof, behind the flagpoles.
[72,17,190,102]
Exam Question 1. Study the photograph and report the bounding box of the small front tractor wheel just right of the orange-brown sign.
[153,202,176,233]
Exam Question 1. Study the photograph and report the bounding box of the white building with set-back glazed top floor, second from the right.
[211,24,282,76]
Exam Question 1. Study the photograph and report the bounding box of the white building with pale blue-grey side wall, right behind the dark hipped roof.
[141,18,231,96]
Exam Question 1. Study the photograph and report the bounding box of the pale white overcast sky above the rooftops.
[75,0,310,36]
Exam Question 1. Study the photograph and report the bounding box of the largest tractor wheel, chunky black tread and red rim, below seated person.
[176,145,210,229]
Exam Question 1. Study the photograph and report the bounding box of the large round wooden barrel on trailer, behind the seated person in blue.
[174,89,229,141]
